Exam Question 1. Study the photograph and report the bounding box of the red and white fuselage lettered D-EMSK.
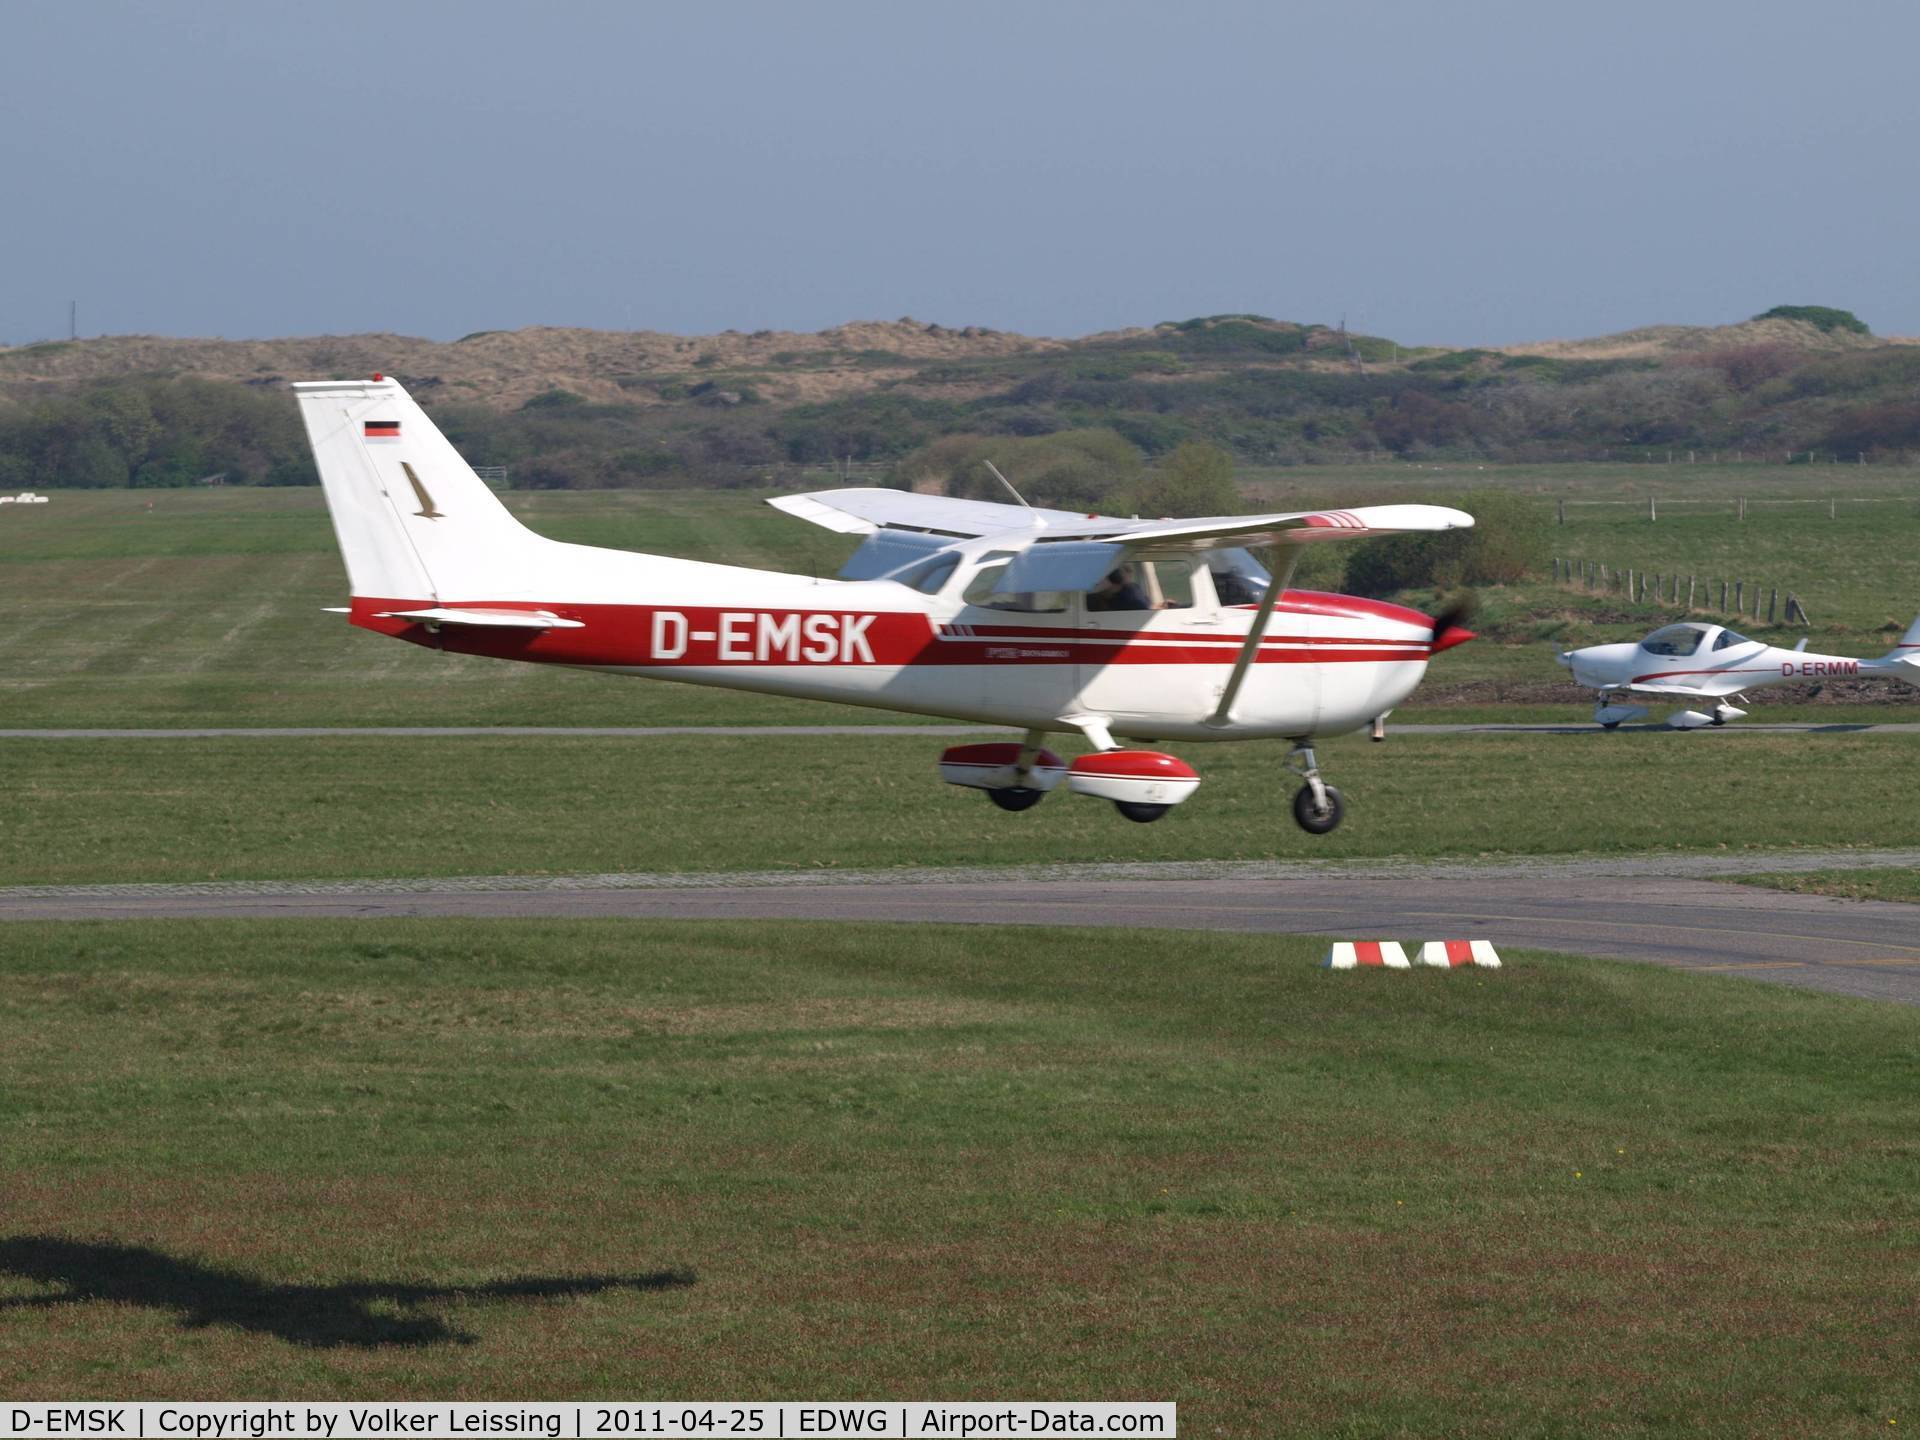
[351,551,1434,739]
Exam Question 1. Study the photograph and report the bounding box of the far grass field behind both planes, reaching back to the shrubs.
[0,485,1920,728]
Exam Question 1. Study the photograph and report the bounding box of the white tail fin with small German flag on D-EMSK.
[294,376,553,603]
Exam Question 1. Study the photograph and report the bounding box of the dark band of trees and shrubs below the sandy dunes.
[0,305,1920,503]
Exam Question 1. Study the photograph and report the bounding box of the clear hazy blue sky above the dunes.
[0,0,1920,344]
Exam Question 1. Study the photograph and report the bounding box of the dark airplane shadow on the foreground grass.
[0,1235,695,1350]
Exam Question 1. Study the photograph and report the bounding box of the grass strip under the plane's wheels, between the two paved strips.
[0,730,1920,883]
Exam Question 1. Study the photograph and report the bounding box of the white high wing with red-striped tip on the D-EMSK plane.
[768,490,1473,589]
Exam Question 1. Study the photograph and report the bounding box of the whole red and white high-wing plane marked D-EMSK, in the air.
[294,374,1473,833]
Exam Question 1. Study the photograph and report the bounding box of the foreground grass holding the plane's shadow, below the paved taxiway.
[0,922,1920,1436]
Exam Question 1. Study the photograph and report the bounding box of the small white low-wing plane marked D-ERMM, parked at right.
[1553,620,1920,730]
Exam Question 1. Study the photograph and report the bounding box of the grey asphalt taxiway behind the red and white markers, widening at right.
[0,851,1920,1004]
